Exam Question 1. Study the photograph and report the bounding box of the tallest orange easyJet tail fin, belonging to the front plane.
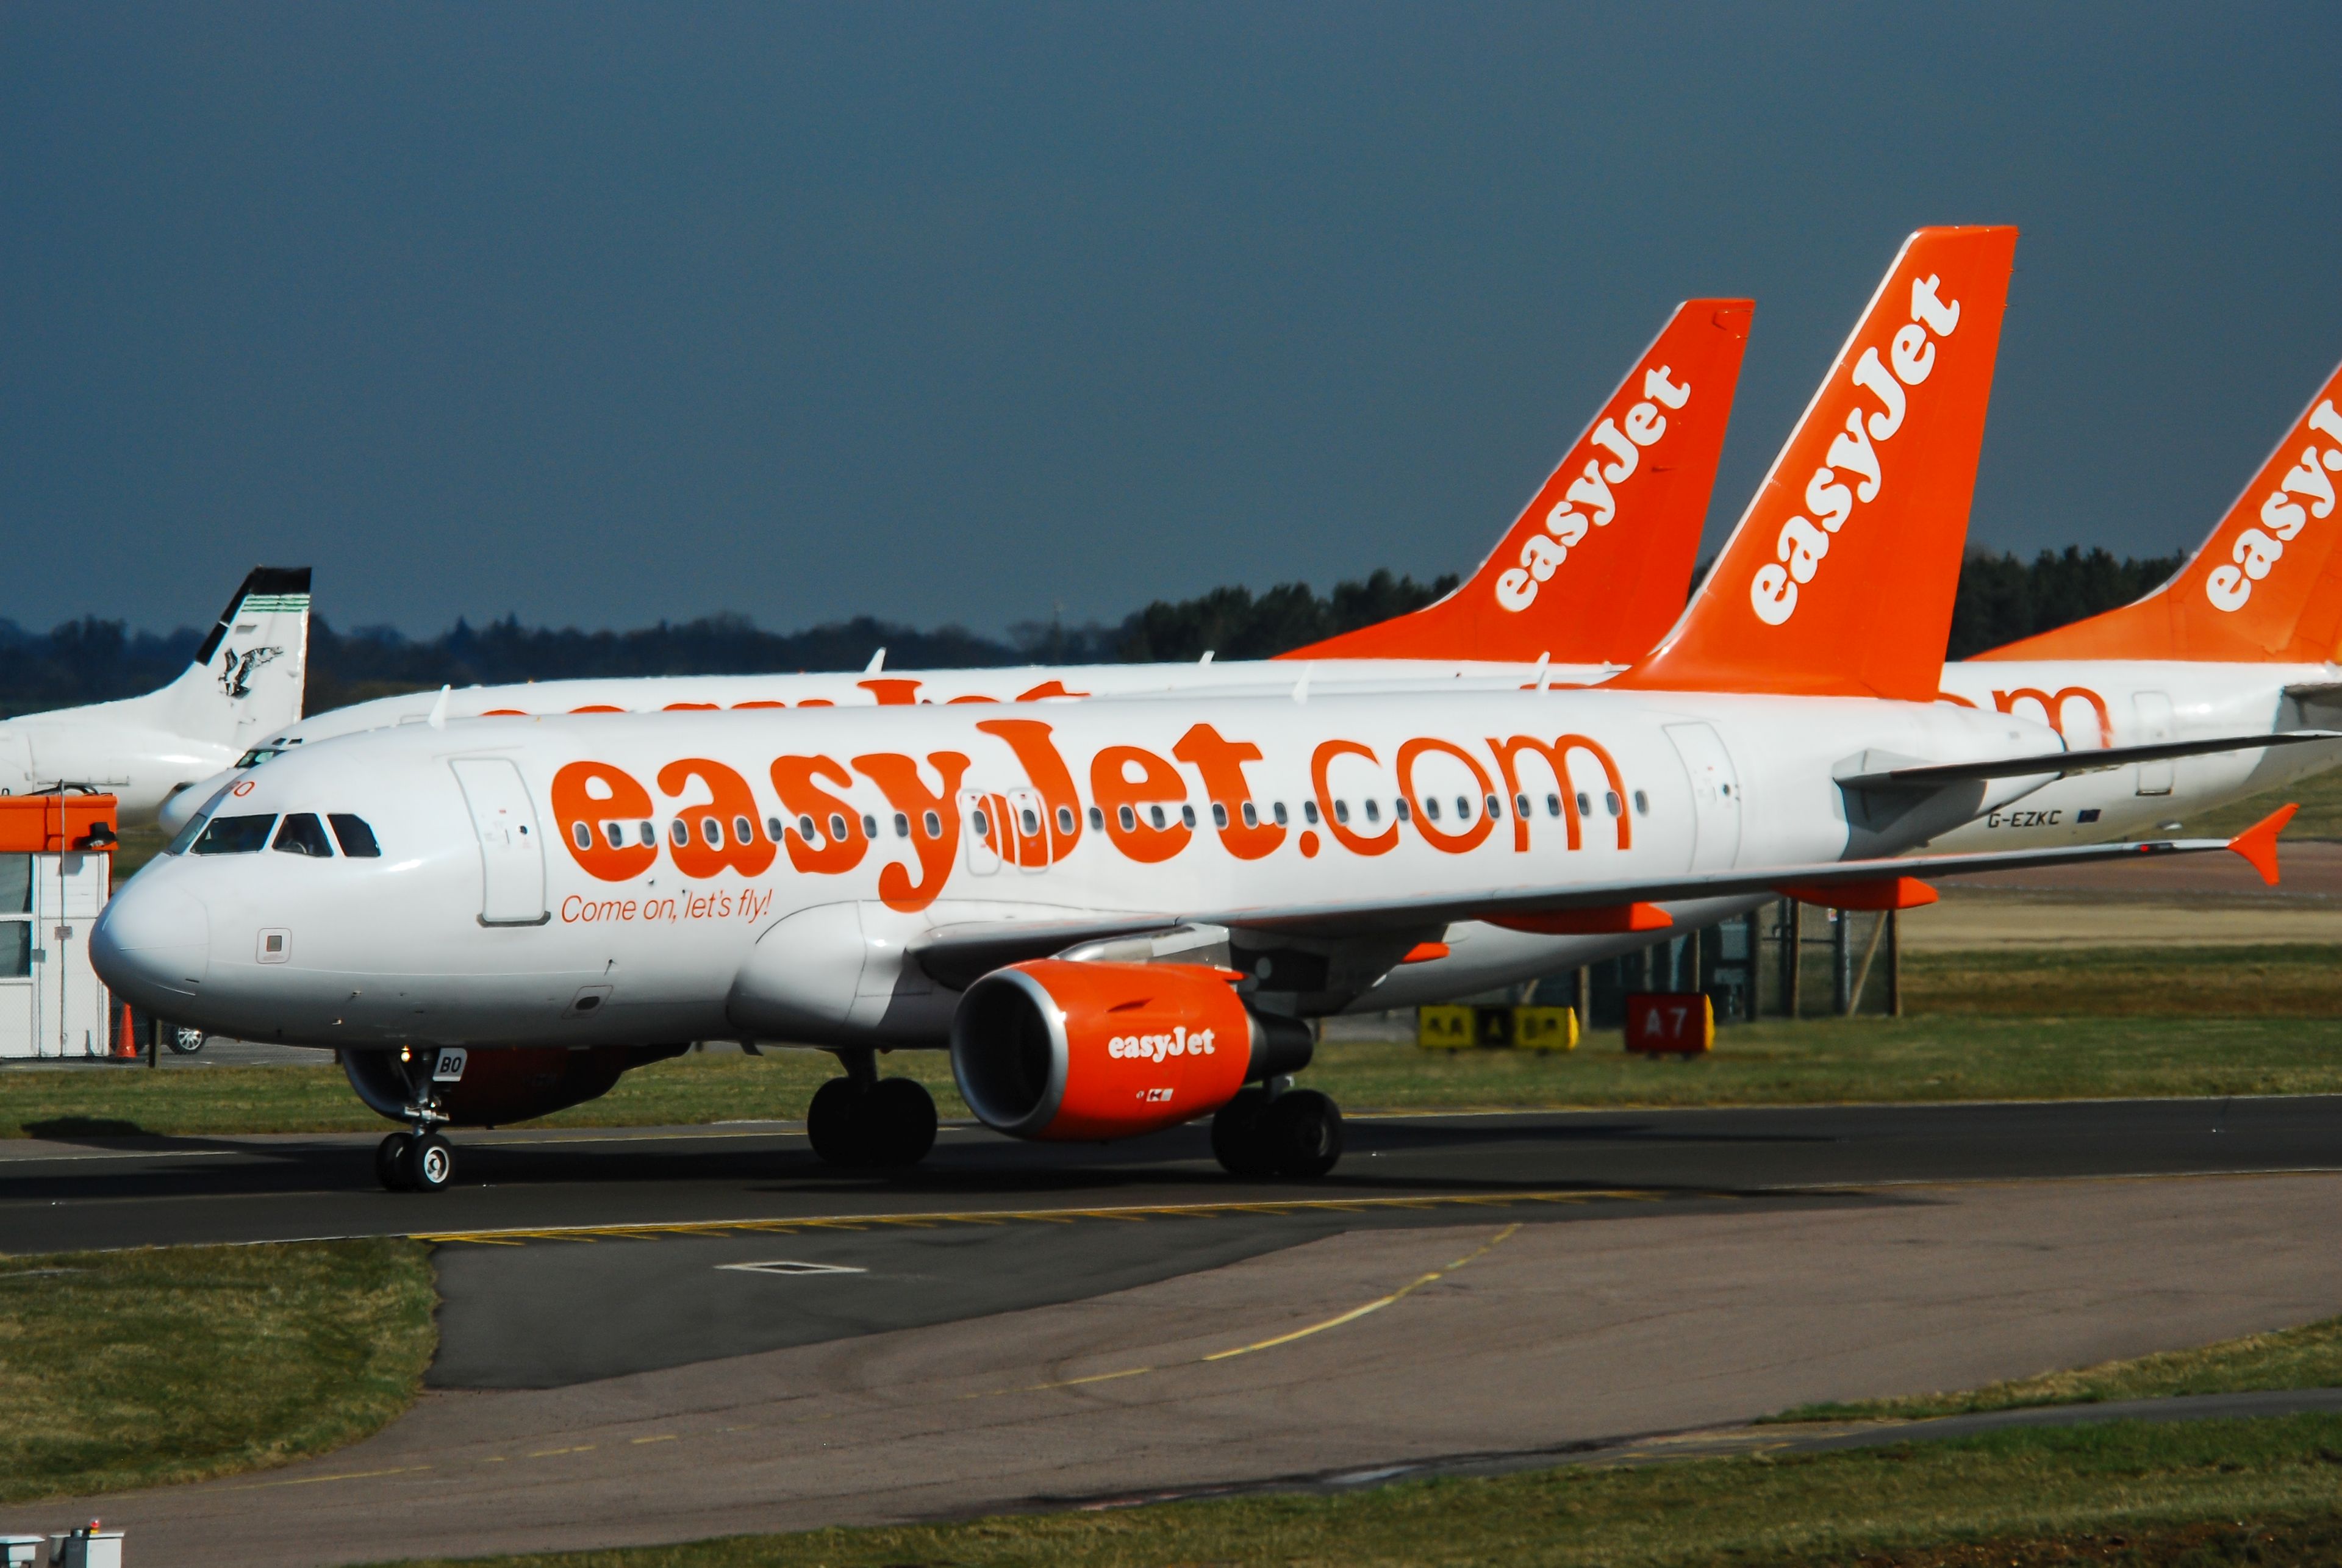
[1614,227,2016,702]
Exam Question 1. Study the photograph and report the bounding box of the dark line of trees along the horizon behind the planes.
[0,548,2178,714]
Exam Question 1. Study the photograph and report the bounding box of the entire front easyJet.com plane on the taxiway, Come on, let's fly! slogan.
[91,229,2281,1189]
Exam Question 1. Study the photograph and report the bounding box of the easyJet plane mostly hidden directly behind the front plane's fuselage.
[151,299,1754,833]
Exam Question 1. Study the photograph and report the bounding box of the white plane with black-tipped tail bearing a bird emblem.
[0,567,309,824]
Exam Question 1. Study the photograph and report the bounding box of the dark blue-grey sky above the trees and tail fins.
[0,2,2342,632]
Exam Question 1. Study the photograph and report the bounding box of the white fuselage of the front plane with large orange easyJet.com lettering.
[94,690,2057,1046]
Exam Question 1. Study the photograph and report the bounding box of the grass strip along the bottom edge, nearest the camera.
[351,1416,2342,1568]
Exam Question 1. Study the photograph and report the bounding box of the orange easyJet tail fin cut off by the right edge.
[1974,356,2342,665]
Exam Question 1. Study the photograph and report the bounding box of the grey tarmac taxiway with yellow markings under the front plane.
[0,1098,2342,1563]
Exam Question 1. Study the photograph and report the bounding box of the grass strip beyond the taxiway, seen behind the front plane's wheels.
[13,945,2342,1137]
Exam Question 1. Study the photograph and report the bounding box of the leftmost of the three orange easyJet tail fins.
[1281,299,1756,665]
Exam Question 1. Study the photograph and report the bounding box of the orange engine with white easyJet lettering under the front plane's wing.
[951,957,1311,1140]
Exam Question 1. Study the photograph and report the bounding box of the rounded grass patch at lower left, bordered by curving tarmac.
[0,1240,438,1503]
